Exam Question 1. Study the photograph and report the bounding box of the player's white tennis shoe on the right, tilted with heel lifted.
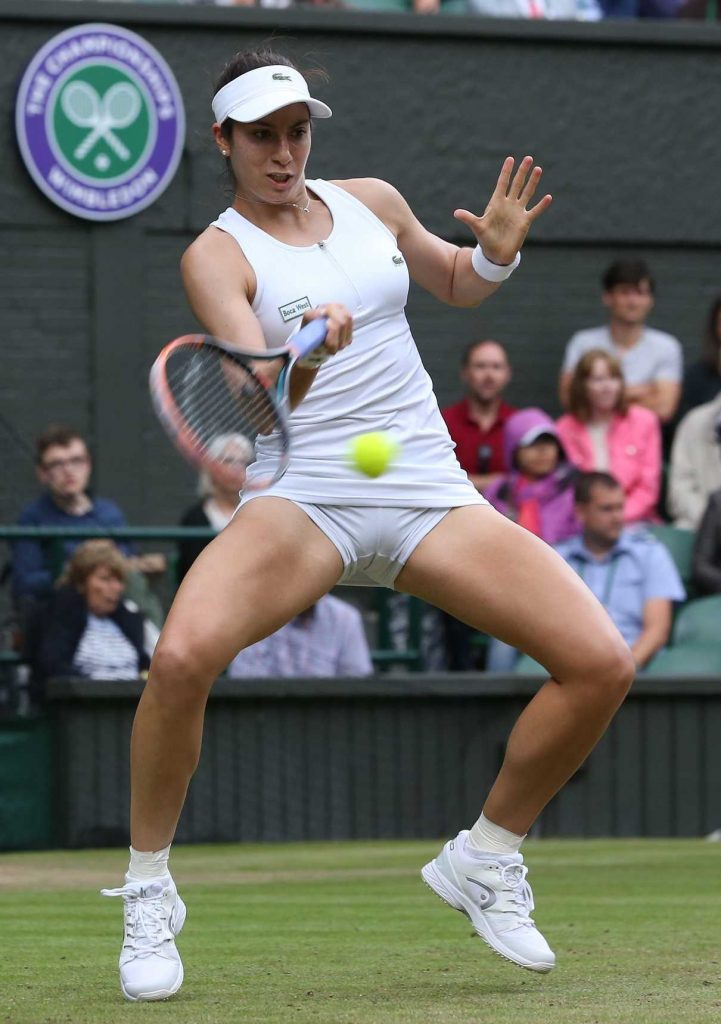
[421,831,556,974]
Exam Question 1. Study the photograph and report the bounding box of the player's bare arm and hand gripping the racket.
[180,227,352,408]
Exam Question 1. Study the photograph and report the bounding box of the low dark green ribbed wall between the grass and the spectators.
[49,673,721,847]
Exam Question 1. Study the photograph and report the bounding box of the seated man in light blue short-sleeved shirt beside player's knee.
[556,473,686,668]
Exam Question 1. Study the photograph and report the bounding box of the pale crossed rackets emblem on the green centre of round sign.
[60,81,142,160]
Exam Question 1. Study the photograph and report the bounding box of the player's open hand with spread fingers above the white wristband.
[454,157,552,266]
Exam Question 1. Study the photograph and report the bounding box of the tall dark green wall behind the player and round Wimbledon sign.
[0,0,721,522]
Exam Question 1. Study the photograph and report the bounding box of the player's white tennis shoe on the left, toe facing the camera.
[100,874,185,1002]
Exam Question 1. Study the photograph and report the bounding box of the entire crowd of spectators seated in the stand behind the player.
[1,258,721,699]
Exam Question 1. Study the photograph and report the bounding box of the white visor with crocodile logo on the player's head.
[213,65,333,124]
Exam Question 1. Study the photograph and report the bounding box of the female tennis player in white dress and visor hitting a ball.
[99,51,634,999]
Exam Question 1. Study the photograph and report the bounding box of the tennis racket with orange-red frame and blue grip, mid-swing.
[150,317,328,490]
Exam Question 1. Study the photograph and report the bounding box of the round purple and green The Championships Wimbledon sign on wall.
[15,25,185,220]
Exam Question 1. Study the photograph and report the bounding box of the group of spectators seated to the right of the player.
[443,259,721,672]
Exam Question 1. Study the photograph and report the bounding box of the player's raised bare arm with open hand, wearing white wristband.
[336,157,551,306]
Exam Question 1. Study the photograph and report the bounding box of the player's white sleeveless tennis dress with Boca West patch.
[213,179,486,585]
